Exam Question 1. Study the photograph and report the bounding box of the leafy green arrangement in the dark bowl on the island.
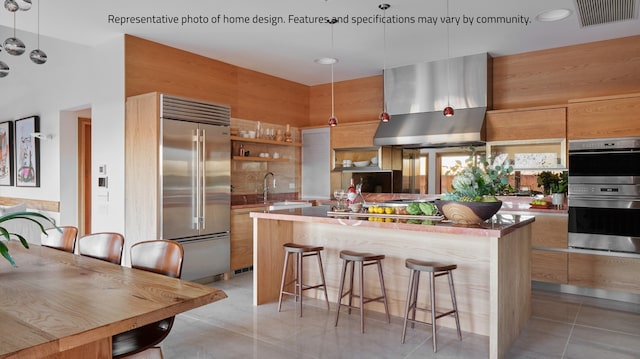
[442,147,513,202]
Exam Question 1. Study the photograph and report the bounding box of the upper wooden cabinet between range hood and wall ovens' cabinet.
[486,106,567,141]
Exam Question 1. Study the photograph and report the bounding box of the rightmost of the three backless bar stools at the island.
[402,259,462,353]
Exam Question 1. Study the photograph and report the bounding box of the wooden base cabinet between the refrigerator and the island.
[231,206,266,271]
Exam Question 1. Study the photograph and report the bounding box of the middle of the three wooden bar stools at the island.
[335,250,391,333]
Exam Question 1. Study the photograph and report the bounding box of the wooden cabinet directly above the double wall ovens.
[567,94,640,140]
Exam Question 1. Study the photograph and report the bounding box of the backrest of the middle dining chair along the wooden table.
[78,232,124,264]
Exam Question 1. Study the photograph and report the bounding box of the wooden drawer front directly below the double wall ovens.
[569,253,640,293]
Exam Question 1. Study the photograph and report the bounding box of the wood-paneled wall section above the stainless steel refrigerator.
[125,35,309,127]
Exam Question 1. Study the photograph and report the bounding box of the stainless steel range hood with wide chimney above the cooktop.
[373,53,493,148]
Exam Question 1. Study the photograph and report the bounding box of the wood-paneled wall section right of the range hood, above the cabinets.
[493,36,640,109]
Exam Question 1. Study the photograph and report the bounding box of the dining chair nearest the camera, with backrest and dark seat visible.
[112,240,184,358]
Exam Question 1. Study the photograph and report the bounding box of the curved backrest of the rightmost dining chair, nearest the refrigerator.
[131,240,184,278]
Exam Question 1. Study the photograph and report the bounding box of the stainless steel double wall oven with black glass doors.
[569,137,640,253]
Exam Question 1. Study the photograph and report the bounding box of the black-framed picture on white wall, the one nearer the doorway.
[15,116,40,187]
